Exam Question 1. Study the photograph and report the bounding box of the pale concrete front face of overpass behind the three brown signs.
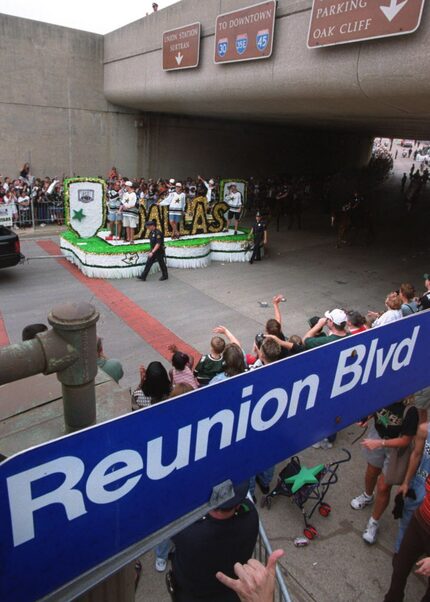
[104,0,430,138]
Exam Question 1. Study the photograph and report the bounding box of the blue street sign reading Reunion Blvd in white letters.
[0,310,430,602]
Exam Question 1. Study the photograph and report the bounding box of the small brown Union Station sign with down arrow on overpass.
[163,23,201,71]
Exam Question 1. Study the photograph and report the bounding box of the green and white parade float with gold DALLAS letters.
[60,178,254,278]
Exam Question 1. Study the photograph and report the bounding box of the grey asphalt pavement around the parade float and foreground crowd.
[0,159,430,602]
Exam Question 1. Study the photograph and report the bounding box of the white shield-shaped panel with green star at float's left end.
[65,178,105,238]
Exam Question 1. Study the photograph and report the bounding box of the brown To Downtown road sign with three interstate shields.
[214,0,276,63]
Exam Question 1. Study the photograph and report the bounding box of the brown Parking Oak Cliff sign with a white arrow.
[308,0,425,48]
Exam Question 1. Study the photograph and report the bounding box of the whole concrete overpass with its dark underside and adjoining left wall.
[0,0,430,178]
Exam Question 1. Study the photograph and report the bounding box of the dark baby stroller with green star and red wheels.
[261,449,351,539]
